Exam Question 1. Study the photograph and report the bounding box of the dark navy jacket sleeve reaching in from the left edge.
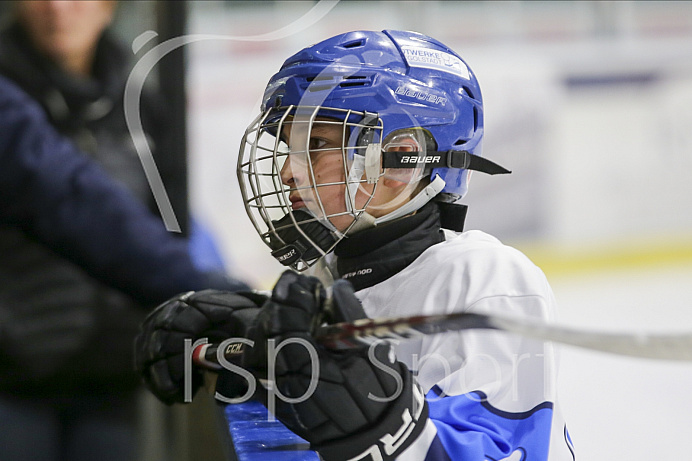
[0,76,245,303]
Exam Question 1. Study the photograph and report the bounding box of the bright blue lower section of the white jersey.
[426,388,553,461]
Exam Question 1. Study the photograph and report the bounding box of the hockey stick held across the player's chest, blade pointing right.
[193,313,692,369]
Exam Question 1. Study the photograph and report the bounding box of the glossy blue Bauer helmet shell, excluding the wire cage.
[263,30,492,198]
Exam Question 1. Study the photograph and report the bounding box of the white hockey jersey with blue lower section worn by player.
[356,230,575,461]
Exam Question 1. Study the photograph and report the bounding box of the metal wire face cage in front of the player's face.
[237,106,383,271]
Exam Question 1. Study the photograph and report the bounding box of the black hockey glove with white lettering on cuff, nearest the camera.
[242,272,428,461]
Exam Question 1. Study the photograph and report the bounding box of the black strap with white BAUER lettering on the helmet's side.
[382,150,511,175]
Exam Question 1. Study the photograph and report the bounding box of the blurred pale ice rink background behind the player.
[5,1,692,461]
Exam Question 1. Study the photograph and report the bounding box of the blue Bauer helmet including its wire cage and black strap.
[238,30,508,265]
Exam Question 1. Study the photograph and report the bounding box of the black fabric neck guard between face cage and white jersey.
[334,202,466,291]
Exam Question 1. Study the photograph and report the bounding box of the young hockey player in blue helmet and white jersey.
[137,30,573,461]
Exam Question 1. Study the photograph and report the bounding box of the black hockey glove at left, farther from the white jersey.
[135,290,267,405]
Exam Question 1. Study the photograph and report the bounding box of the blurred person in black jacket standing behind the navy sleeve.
[0,1,232,460]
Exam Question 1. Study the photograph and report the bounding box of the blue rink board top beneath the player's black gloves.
[223,401,320,461]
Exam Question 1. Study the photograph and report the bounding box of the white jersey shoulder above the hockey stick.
[359,231,554,316]
